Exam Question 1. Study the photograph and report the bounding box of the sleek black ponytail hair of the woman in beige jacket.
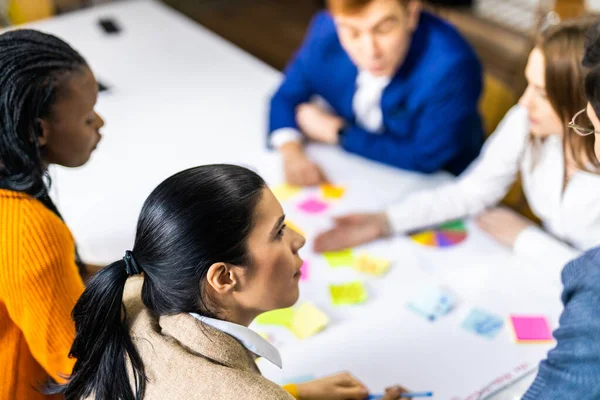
[56,165,265,400]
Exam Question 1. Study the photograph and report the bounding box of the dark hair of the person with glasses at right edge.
[582,20,600,122]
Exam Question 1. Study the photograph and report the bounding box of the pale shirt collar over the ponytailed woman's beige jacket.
[190,313,282,368]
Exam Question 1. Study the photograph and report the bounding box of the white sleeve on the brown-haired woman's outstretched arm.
[386,105,529,234]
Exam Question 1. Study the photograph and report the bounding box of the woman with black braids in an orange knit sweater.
[0,30,104,400]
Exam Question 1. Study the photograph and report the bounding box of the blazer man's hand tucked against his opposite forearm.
[296,103,344,144]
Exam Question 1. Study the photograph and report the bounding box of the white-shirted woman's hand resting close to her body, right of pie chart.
[476,207,535,247]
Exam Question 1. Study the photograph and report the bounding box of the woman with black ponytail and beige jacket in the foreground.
[60,165,402,400]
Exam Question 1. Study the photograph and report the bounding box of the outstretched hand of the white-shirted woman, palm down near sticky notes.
[314,213,391,253]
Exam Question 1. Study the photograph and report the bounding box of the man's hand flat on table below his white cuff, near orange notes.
[281,142,327,186]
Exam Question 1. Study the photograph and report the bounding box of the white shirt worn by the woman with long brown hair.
[387,105,600,282]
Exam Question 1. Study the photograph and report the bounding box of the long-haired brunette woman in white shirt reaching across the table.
[315,18,600,281]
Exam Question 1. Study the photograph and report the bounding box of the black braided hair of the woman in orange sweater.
[0,29,87,273]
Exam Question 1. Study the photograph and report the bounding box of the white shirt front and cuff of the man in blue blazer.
[271,71,391,149]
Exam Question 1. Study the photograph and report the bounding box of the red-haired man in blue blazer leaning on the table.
[269,0,483,185]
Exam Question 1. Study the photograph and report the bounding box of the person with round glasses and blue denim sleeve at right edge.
[523,21,600,400]
